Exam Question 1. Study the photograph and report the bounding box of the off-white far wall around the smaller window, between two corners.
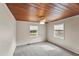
[16,21,46,45]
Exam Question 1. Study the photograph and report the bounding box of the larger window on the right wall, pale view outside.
[54,23,64,39]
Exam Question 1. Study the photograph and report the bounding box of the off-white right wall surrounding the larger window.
[47,15,79,54]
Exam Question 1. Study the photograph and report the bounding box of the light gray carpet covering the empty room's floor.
[14,42,77,56]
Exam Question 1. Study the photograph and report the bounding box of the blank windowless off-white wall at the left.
[0,3,16,56]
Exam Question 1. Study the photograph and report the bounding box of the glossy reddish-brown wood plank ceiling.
[7,3,79,22]
